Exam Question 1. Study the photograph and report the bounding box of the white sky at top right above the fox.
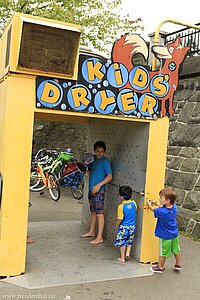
[122,0,200,41]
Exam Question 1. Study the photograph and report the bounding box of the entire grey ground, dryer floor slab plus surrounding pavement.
[0,192,200,300]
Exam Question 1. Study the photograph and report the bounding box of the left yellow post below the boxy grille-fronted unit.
[0,75,35,276]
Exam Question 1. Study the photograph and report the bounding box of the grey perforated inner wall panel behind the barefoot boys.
[83,119,149,260]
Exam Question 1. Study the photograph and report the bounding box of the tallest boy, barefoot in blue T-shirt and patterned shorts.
[81,141,112,246]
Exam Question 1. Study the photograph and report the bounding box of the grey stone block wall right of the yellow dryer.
[165,57,200,238]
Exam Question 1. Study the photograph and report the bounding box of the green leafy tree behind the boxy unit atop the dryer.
[0,0,142,52]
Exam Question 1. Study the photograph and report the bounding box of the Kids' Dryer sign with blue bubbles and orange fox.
[36,34,190,119]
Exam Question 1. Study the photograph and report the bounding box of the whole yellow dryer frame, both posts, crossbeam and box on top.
[0,13,169,276]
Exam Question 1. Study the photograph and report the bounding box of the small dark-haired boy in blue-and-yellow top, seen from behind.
[114,185,137,263]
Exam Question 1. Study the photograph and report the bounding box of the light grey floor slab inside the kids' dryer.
[5,221,152,289]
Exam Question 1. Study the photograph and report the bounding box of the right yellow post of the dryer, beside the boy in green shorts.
[140,117,169,263]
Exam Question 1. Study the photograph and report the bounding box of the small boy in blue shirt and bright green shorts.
[147,188,181,273]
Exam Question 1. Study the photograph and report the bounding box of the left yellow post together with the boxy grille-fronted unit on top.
[0,13,80,276]
